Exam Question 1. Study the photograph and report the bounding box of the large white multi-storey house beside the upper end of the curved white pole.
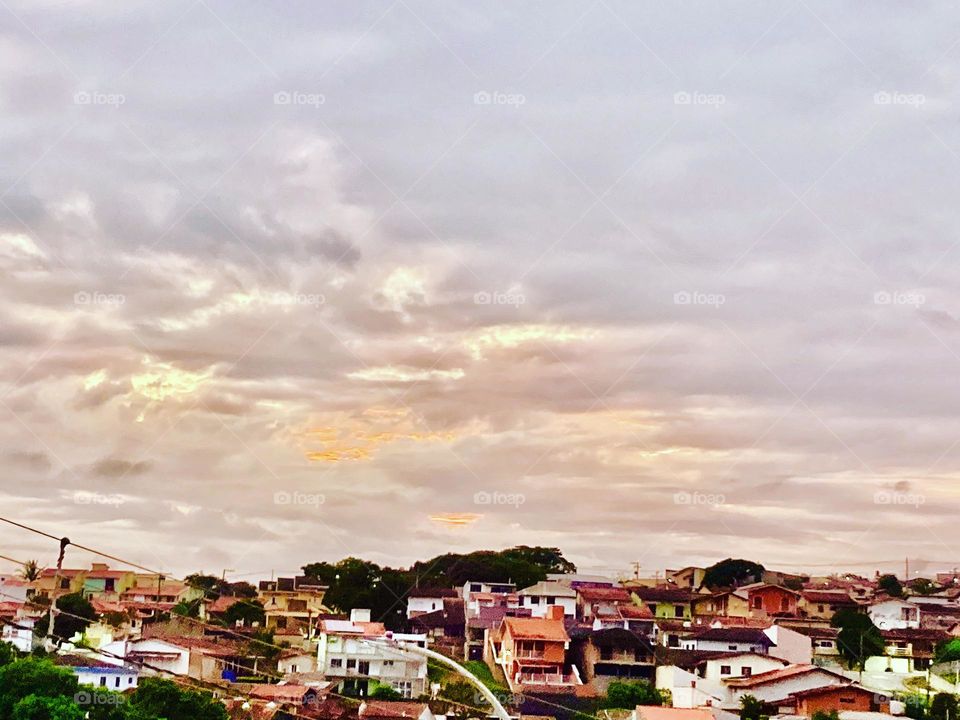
[317,609,427,698]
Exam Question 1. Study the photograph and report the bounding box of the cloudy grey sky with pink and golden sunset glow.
[0,0,960,579]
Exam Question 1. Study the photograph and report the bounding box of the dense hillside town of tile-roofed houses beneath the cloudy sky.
[0,548,960,720]
